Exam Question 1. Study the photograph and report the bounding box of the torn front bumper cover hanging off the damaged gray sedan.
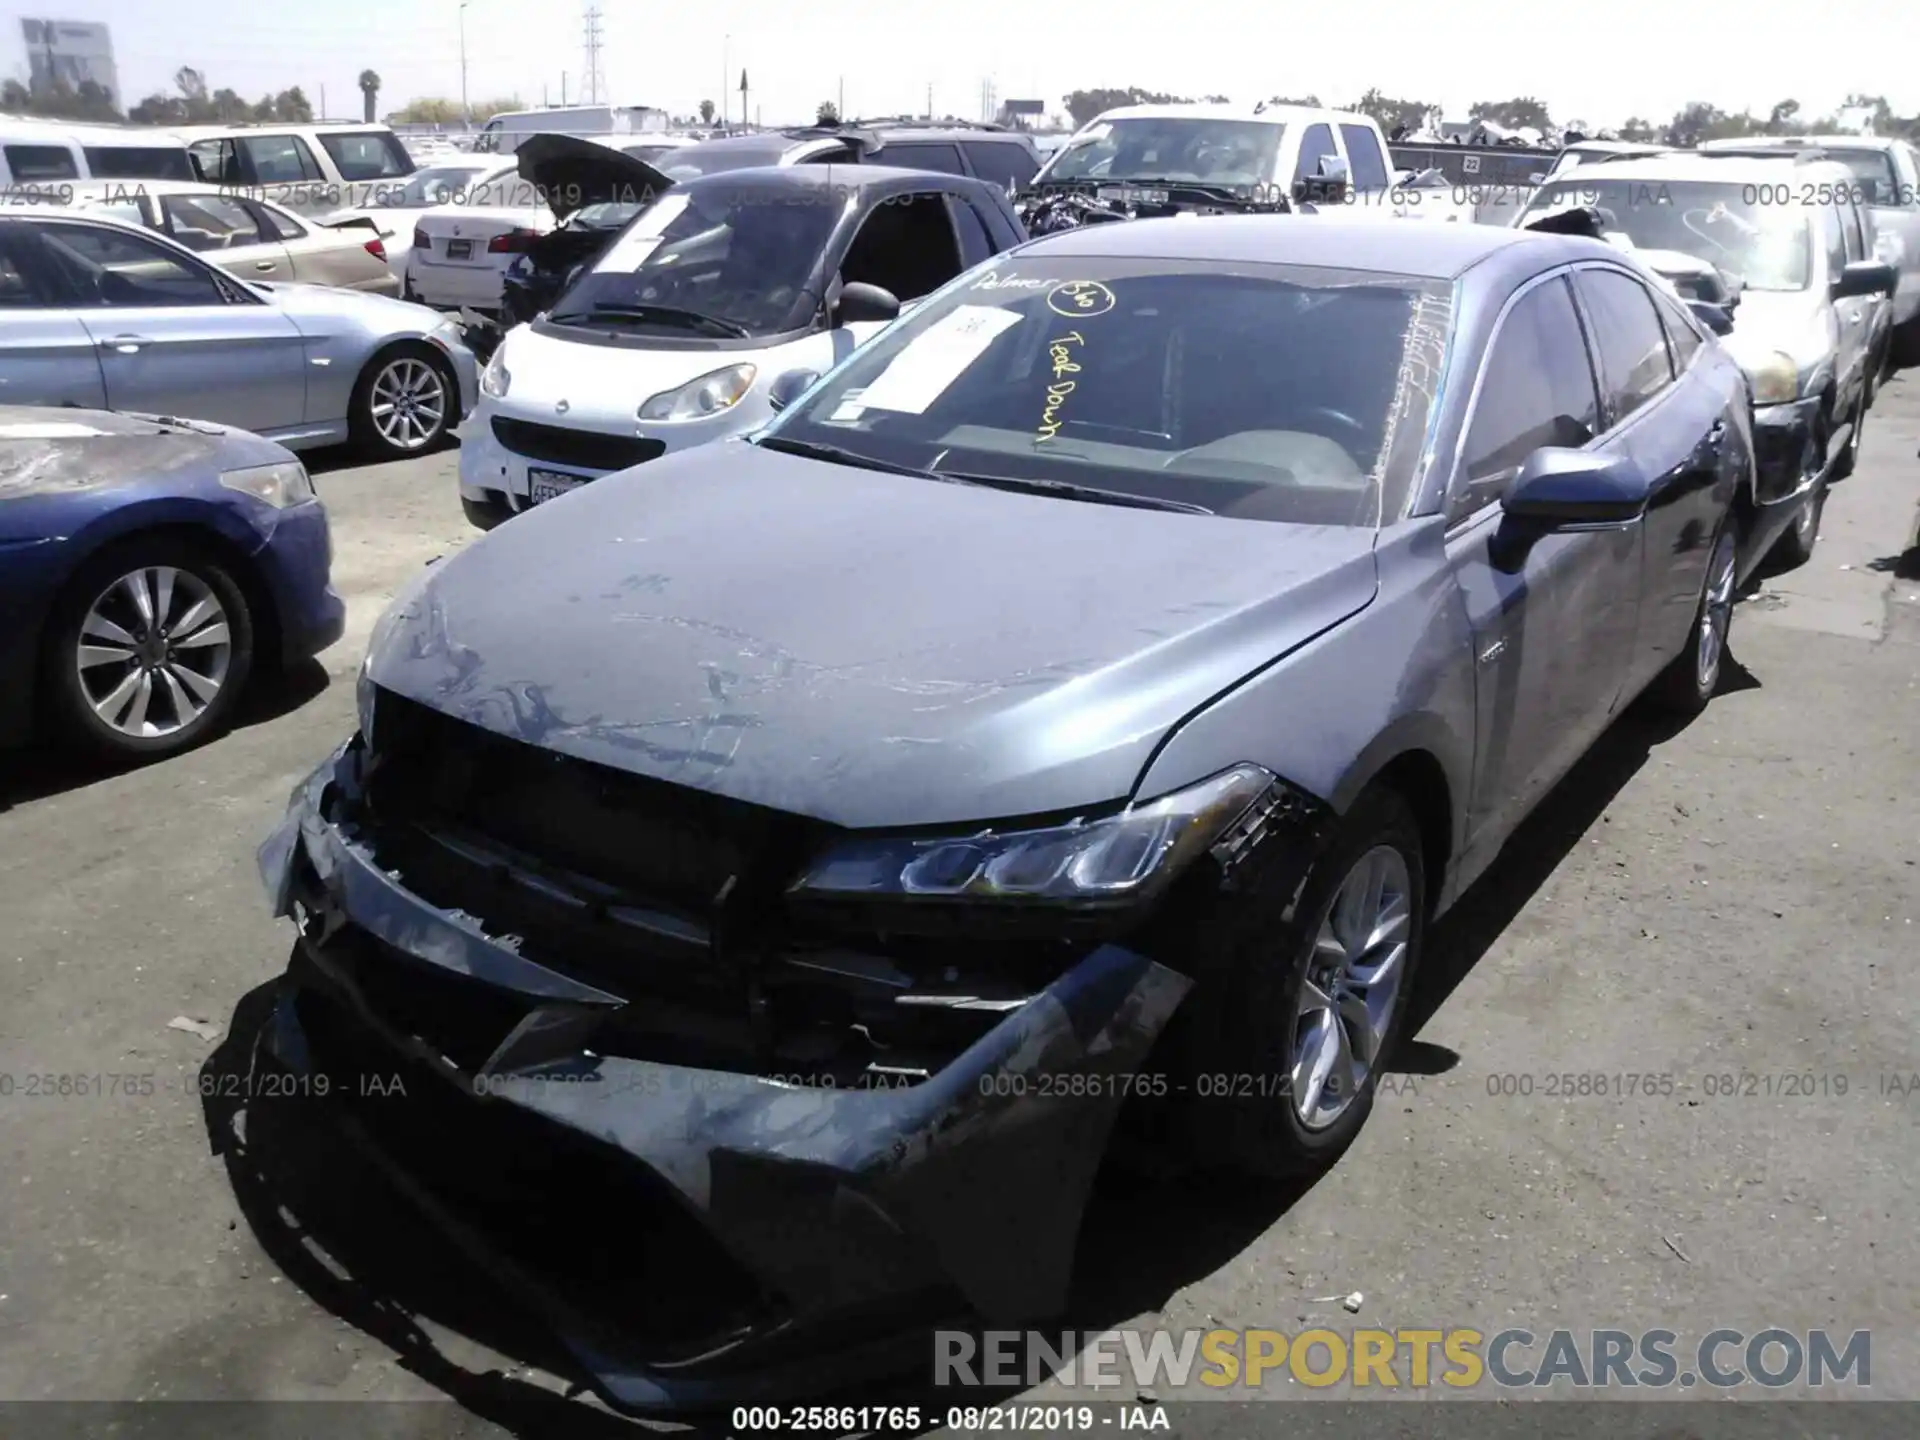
[259,739,1190,1409]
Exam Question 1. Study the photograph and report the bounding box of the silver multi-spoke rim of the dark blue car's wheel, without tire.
[73,564,232,739]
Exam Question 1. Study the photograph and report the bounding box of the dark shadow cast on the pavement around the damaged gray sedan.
[200,655,1759,1440]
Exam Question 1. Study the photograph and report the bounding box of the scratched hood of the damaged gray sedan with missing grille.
[369,442,1377,826]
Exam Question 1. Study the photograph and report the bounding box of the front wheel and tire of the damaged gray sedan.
[1181,787,1427,1179]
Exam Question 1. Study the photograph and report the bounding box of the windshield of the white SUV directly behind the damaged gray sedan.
[1519,179,1811,290]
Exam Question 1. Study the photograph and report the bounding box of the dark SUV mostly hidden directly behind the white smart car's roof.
[653,121,1041,190]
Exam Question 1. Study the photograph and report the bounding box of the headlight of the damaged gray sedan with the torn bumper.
[791,764,1275,902]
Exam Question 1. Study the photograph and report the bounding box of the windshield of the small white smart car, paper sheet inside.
[549,177,847,336]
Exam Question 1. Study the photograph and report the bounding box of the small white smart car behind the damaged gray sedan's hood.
[461,165,1025,528]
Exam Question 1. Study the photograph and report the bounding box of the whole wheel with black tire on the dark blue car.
[42,536,255,760]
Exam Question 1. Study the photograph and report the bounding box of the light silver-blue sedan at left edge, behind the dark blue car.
[0,211,478,459]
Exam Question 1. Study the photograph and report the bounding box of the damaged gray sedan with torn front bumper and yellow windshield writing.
[261,217,1768,1409]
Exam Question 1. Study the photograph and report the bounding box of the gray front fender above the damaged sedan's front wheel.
[1139,516,1475,904]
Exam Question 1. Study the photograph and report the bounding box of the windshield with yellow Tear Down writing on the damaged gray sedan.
[762,257,1452,526]
